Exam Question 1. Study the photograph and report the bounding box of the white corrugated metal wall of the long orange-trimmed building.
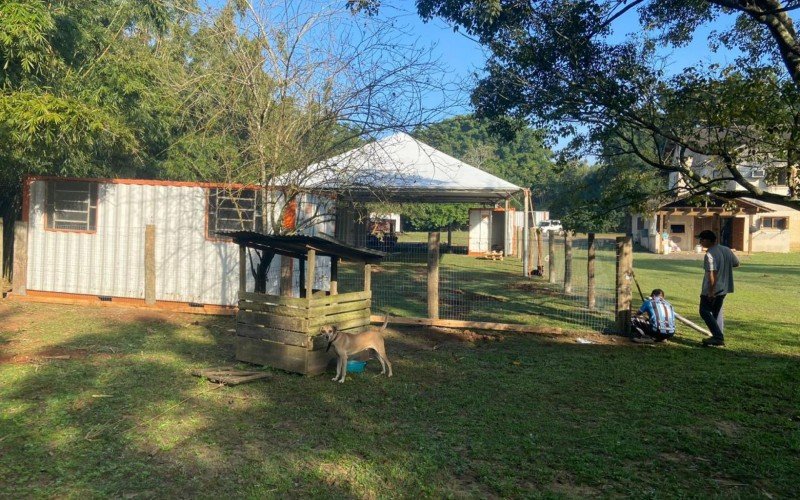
[28,181,330,305]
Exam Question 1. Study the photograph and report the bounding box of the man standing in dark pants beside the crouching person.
[697,230,739,346]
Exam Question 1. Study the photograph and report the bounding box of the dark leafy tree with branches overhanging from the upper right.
[356,0,800,208]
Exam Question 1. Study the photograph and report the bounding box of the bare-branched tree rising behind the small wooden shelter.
[166,0,450,233]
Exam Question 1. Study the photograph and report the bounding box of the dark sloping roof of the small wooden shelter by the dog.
[217,231,386,264]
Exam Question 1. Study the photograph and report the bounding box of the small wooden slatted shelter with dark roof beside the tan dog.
[225,231,386,375]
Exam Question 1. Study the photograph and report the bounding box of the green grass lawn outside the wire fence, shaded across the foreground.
[0,253,800,498]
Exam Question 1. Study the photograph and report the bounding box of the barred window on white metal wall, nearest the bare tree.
[206,188,261,238]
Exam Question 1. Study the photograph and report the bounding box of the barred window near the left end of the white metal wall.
[45,181,97,231]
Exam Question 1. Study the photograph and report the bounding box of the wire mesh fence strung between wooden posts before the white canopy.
[339,233,616,331]
